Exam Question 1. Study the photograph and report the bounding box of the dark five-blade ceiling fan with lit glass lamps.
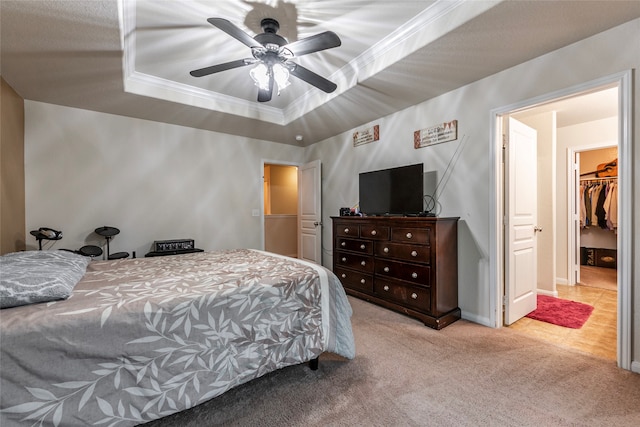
[190,18,342,102]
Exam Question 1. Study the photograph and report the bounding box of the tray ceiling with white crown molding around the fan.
[0,0,640,145]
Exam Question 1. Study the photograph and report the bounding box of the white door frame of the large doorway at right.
[489,70,633,370]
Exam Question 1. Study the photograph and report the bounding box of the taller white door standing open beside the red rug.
[504,117,538,325]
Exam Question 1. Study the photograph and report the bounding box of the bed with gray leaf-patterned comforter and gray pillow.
[0,249,355,427]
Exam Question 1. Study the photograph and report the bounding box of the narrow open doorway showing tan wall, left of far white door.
[263,163,298,258]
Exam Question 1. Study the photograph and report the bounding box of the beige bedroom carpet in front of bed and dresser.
[149,298,640,427]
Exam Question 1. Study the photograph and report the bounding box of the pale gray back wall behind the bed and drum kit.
[25,101,303,256]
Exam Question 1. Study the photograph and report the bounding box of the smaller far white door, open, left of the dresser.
[298,160,322,265]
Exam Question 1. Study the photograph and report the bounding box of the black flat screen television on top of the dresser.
[359,163,424,216]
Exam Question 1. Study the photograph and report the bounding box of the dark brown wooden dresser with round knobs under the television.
[332,216,460,329]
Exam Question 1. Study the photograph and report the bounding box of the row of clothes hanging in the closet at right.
[580,180,618,231]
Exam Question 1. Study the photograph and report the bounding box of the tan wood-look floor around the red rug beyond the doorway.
[509,266,618,361]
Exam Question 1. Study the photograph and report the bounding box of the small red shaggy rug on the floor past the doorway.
[526,295,593,329]
